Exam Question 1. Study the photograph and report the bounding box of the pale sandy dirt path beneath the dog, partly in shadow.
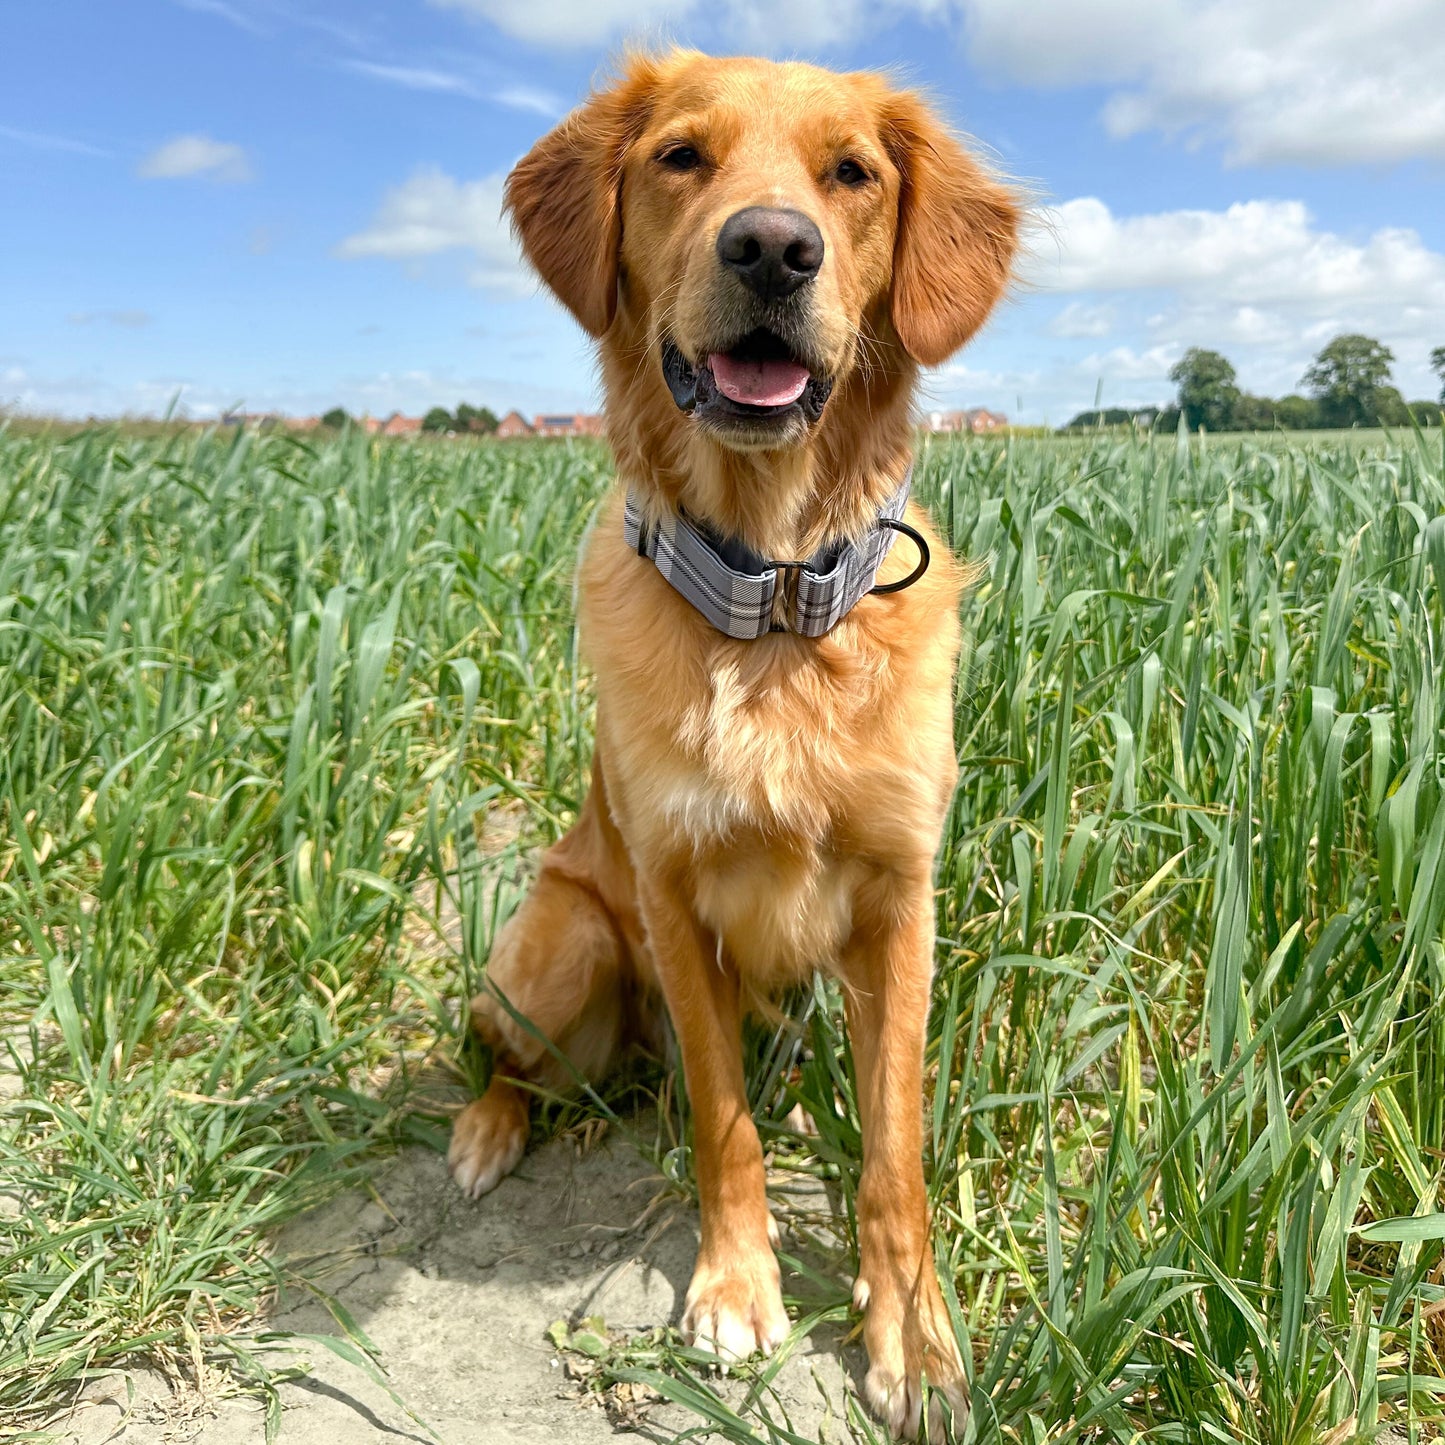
[61,1137,861,1445]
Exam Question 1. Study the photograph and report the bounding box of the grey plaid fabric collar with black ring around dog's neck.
[623,464,929,642]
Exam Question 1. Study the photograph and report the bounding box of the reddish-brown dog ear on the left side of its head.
[506,56,657,337]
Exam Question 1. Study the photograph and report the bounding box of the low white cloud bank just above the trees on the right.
[1005,197,1445,413]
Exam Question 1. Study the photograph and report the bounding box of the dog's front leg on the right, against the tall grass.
[842,871,964,1436]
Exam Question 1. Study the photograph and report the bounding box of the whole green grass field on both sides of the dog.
[0,429,1445,1445]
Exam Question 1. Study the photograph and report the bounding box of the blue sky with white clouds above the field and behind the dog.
[0,0,1445,423]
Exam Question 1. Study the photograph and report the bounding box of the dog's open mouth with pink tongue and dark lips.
[662,328,832,423]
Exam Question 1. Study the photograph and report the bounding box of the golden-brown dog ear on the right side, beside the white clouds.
[883,94,1020,366]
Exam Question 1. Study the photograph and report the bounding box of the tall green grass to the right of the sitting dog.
[928,439,1445,1445]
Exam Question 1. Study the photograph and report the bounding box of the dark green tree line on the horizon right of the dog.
[1064,334,1445,432]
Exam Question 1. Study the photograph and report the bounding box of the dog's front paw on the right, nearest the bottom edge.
[853,1260,968,1441]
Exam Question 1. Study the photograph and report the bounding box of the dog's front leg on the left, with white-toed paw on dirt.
[639,881,788,1360]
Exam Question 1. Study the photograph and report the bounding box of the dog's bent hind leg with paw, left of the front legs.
[447,770,633,1198]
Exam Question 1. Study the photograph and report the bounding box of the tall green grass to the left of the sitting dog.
[0,431,604,1420]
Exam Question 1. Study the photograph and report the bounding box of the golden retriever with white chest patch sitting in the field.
[449,52,1020,1433]
